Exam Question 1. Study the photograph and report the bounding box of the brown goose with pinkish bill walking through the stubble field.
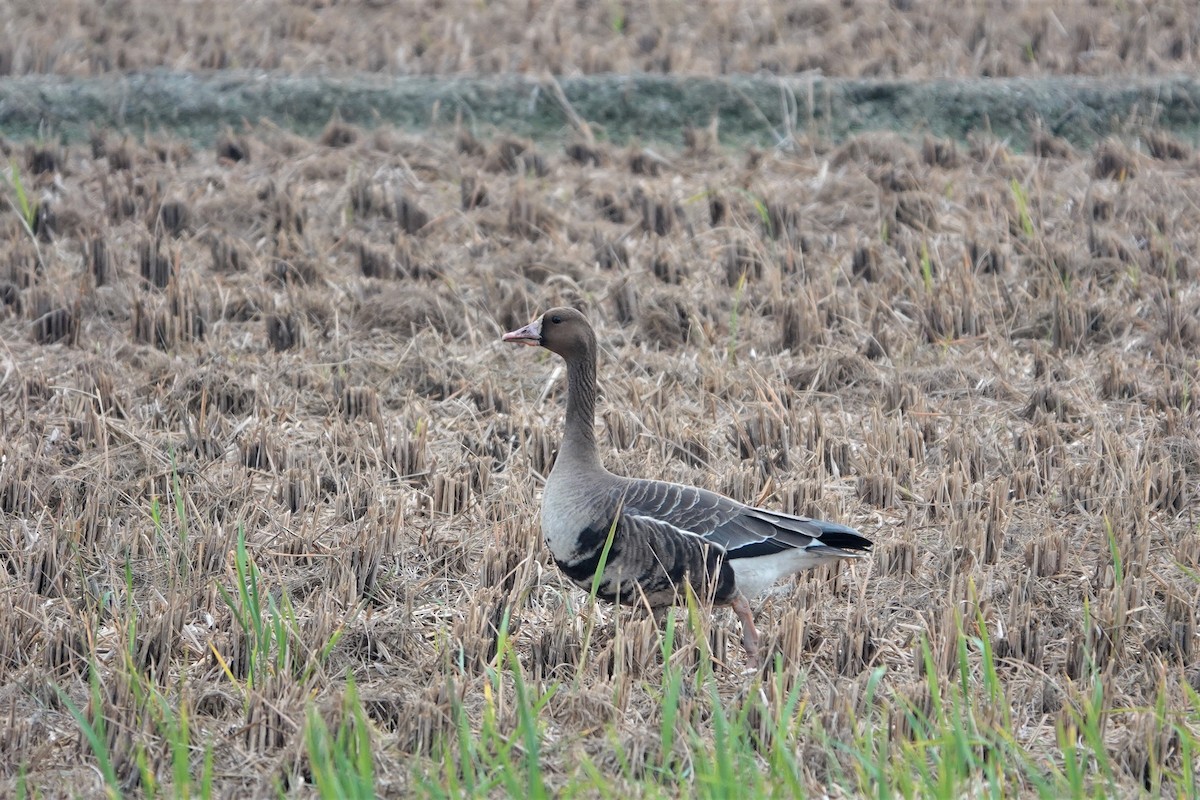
[503,308,871,667]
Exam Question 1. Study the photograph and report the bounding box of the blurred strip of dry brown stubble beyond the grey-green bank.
[0,0,1200,78]
